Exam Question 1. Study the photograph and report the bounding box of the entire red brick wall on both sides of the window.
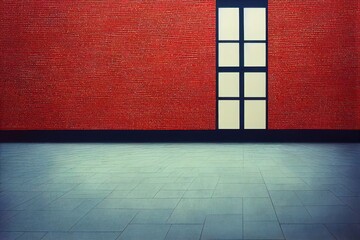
[0,0,360,130]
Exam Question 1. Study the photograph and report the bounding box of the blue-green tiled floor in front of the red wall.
[0,143,360,240]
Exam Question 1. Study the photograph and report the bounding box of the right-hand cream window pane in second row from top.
[244,43,266,67]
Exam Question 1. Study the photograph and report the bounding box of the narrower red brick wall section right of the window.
[268,0,360,129]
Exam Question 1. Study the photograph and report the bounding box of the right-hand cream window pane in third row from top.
[244,72,266,97]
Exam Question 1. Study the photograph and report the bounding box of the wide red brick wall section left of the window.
[0,0,216,129]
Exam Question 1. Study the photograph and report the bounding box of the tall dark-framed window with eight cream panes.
[217,0,267,129]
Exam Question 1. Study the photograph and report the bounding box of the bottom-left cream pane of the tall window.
[219,100,240,129]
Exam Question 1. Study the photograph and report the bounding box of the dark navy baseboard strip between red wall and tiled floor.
[0,130,360,143]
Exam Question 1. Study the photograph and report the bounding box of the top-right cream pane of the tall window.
[244,8,266,40]
